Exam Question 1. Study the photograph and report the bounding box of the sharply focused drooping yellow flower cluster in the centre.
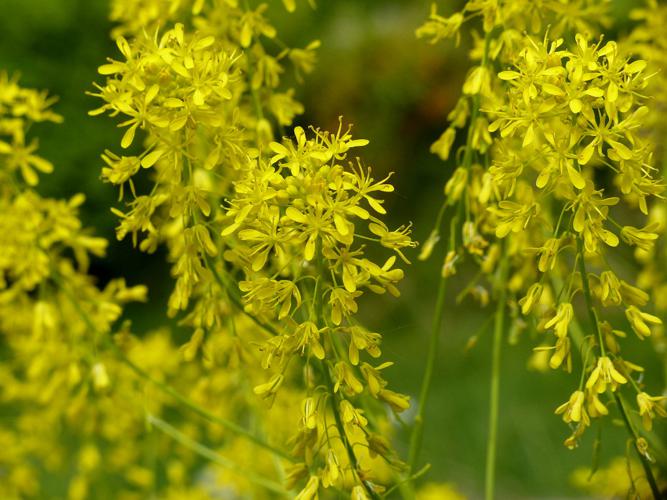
[222,125,414,495]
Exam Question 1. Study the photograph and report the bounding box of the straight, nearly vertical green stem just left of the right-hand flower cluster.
[484,253,509,500]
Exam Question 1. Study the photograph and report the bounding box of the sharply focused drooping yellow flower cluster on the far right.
[488,30,663,446]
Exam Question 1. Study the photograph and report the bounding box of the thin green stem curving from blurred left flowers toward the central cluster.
[52,272,295,462]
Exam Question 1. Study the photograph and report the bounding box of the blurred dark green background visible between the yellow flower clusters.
[0,0,662,498]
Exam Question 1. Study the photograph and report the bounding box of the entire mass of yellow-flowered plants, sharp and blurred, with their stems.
[0,0,667,500]
